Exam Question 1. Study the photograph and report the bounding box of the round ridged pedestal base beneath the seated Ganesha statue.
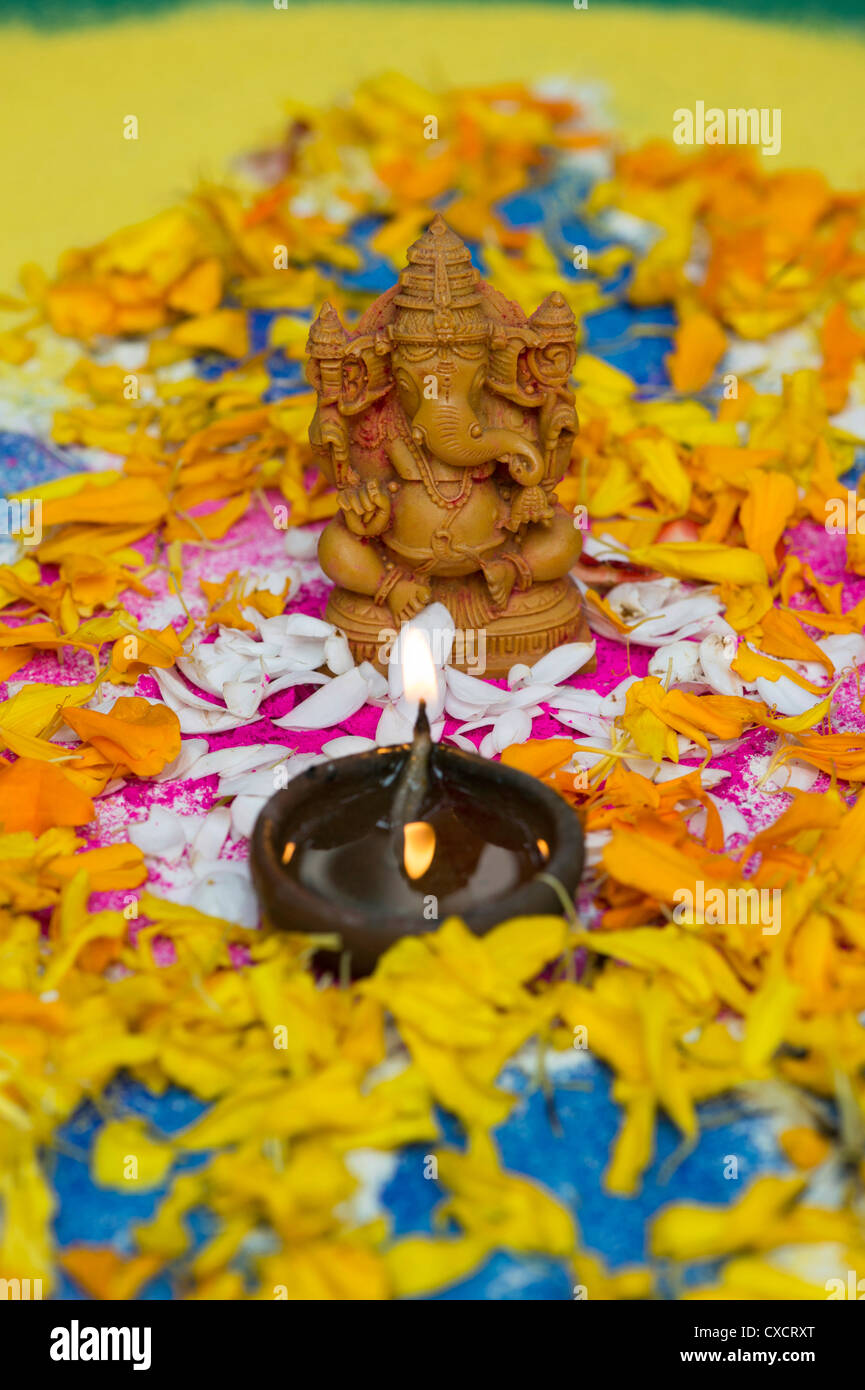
[325,575,595,677]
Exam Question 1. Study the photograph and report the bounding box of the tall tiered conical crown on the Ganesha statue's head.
[394,213,490,342]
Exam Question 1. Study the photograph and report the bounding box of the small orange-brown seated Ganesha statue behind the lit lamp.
[307,215,588,676]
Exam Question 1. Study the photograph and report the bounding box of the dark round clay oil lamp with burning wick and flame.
[250,630,583,974]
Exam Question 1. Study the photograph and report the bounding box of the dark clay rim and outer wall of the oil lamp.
[250,744,583,974]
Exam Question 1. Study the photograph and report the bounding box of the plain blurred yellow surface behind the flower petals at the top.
[0,0,865,289]
